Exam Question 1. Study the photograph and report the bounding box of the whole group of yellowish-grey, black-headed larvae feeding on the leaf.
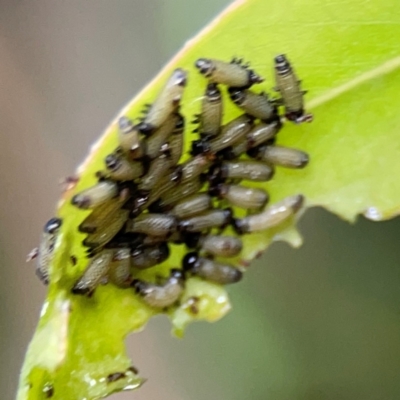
[30,55,312,309]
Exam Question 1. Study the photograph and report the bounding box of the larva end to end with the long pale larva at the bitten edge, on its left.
[179,208,232,232]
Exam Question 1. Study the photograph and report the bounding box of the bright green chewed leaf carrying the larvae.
[18,0,400,400]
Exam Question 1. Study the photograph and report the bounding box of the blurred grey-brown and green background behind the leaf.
[0,0,400,400]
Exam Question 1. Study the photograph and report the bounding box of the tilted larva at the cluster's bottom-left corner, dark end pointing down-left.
[71,250,114,296]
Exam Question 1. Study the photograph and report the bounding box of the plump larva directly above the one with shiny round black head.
[185,233,242,257]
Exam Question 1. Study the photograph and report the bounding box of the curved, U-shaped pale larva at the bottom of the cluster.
[132,269,184,308]
